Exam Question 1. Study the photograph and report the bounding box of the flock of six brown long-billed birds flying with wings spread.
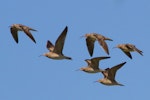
[10,24,143,86]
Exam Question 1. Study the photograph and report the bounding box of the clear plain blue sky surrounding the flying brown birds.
[0,0,150,100]
